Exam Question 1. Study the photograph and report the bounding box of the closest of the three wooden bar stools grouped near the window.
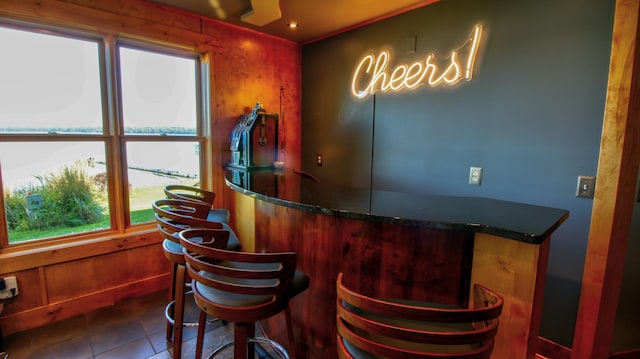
[179,229,309,359]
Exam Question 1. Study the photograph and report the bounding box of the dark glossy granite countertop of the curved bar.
[226,168,569,244]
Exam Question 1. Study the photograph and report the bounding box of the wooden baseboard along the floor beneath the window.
[0,273,171,336]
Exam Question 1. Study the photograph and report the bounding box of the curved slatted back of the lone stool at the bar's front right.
[337,273,503,359]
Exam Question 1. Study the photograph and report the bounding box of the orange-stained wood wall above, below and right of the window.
[0,0,301,335]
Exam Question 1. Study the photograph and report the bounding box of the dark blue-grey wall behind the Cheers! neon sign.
[302,0,615,346]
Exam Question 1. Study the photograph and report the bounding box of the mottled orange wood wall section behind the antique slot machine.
[204,23,301,207]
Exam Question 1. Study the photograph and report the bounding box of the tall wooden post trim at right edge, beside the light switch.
[571,0,640,359]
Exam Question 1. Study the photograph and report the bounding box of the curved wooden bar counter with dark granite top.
[225,168,569,359]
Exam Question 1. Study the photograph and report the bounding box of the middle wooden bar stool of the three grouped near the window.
[152,199,240,359]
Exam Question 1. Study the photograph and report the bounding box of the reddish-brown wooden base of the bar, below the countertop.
[232,193,549,359]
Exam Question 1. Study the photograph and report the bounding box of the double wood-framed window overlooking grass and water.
[0,24,205,245]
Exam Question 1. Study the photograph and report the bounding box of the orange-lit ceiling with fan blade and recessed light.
[142,0,437,43]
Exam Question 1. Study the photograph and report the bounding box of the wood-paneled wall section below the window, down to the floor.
[0,229,165,335]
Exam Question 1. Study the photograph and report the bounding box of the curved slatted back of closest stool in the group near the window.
[179,229,296,323]
